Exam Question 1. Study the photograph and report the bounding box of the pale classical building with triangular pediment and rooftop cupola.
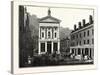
[38,9,60,54]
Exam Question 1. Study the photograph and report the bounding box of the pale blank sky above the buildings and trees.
[26,6,93,29]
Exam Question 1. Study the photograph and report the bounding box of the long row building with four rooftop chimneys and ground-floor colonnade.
[70,15,94,59]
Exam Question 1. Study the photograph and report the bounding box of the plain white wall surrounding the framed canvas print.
[0,0,100,75]
